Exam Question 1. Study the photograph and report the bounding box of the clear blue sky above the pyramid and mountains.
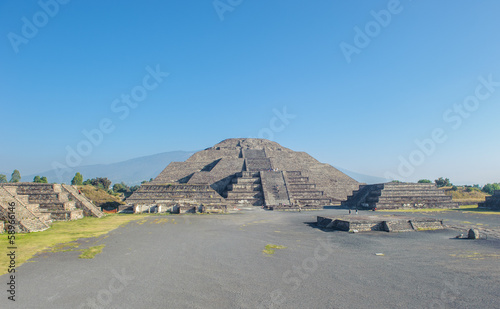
[0,0,500,184]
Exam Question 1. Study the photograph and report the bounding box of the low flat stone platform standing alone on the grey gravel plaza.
[317,215,444,232]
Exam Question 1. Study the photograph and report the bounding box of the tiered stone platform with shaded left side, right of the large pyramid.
[342,182,458,209]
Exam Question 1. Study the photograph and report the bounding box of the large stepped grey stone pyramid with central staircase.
[124,138,359,213]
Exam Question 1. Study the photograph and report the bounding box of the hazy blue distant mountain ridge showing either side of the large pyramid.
[21,150,387,186]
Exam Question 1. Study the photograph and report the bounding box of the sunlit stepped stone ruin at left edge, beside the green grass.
[0,182,103,232]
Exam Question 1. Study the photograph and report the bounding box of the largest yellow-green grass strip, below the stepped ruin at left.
[0,214,148,275]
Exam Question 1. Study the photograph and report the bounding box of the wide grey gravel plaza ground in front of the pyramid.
[0,208,500,308]
